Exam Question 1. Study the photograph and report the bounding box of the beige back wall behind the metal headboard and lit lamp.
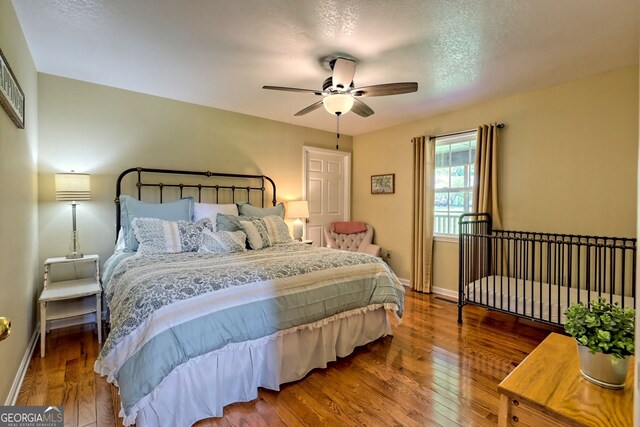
[38,74,352,266]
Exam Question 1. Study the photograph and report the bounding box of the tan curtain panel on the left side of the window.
[411,136,435,293]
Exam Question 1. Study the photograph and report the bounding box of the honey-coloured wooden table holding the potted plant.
[498,333,634,427]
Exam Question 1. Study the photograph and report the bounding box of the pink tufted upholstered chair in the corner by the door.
[324,221,380,256]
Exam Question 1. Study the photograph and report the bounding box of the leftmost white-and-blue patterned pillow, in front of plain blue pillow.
[131,218,213,255]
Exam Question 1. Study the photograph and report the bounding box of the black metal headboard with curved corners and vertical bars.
[115,167,276,235]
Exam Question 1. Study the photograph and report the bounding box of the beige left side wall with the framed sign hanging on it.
[0,0,39,404]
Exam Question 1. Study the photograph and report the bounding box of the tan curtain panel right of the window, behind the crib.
[472,123,502,230]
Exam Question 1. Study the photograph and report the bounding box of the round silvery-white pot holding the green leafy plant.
[578,345,629,389]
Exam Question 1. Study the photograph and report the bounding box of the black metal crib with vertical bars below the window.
[458,213,636,326]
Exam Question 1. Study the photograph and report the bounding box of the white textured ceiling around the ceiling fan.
[13,0,640,135]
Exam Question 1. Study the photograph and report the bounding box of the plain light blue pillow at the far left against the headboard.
[120,196,193,252]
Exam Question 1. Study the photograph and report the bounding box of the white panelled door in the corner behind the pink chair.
[302,147,351,246]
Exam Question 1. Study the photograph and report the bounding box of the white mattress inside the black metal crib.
[465,276,634,324]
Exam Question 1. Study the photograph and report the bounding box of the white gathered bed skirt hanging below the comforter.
[133,308,391,427]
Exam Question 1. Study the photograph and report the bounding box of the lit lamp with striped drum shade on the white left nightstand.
[56,171,91,259]
